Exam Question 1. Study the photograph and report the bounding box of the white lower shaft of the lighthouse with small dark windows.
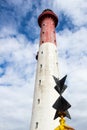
[30,11,58,130]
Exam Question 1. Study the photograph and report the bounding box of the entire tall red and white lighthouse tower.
[30,9,59,130]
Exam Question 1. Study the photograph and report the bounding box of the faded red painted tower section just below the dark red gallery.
[40,17,56,45]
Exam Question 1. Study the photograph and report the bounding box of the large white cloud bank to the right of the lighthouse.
[57,27,87,130]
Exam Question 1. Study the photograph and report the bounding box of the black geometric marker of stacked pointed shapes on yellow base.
[53,75,71,120]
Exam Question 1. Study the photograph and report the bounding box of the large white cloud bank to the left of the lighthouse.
[0,30,38,130]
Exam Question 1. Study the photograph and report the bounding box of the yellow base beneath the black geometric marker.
[54,116,74,130]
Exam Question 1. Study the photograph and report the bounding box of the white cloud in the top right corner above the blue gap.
[53,0,87,26]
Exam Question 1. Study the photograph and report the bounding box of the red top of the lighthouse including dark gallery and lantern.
[38,9,58,45]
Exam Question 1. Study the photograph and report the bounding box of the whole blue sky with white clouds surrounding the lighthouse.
[0,0,87,130]
